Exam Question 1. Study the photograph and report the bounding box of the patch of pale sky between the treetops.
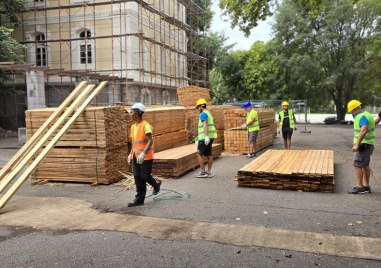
[211,0,271,50]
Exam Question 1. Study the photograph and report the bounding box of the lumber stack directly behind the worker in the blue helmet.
[224,109,275,154]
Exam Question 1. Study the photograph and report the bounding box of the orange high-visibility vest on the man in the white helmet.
[131,120,154,160]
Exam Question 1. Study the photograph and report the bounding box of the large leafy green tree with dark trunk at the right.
[273,0,381,120]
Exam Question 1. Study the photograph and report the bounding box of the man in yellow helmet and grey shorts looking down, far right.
[348,100,375,194]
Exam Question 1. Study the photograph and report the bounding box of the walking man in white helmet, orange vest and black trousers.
[127,103,161,207]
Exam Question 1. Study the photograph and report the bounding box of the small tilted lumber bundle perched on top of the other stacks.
[177,86,211,107]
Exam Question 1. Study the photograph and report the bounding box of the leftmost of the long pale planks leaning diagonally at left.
[0,81,87,181]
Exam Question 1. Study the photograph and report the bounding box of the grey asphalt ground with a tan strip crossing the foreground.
[0,125,381,267]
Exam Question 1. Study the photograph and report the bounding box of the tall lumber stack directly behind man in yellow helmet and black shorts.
[186,105,236,147]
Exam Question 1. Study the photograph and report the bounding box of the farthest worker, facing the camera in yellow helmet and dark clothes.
[278,101,296,150]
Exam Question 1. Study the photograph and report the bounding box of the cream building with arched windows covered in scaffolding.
[0,0,208,129]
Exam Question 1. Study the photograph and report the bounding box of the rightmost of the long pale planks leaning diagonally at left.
[0,81,107,208]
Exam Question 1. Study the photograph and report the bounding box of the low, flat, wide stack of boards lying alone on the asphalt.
[236,150,335,192]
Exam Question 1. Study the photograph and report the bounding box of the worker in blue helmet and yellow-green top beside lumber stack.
[241,101,259,158]
